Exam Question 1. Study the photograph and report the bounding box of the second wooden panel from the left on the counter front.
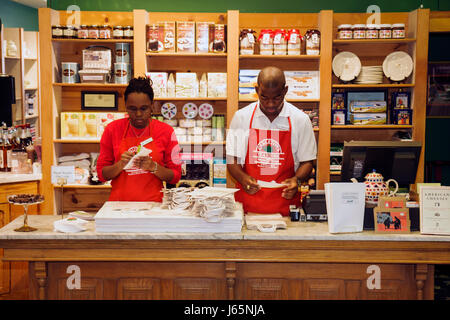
[117,278,162,300]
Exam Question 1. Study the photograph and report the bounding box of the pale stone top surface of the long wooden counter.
[0,215,450,243]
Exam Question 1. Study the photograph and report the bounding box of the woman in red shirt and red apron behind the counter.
[97,77,181,202]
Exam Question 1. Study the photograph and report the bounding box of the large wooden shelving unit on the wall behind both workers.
[39,8,429,213]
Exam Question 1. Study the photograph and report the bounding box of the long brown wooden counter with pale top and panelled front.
[0,216,450,299]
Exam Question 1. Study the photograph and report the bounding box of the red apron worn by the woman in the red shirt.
[109,121,163,202]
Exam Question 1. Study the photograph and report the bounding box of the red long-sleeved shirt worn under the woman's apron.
[97,118,181,184]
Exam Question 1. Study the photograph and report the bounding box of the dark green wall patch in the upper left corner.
[0,0,39,31]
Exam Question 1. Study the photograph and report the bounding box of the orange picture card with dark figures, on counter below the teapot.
[373,207,411,233]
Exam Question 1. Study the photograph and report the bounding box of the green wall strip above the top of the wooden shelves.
[48,0,450,12]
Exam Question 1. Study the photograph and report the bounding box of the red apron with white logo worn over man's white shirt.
[235,105,300,216]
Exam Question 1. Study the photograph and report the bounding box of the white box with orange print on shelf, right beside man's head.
[284,71,319,99]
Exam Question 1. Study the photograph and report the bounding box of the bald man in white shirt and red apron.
[226,67,317,216]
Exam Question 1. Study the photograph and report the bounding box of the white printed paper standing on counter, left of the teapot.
[325,182,366,233]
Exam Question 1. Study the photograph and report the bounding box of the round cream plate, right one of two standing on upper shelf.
[383,51,414,81]
